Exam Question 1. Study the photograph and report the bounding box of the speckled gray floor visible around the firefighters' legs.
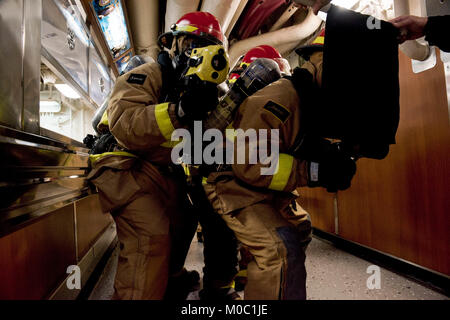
[89,238,449,300]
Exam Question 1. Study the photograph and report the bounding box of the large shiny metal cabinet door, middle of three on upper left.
[41,0,90,93]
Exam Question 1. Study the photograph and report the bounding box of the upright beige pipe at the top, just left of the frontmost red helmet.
[127,0,159,60]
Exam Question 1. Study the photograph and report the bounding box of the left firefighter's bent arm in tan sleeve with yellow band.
[107,63,181,151]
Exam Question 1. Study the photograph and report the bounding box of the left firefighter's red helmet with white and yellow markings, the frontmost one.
[158,11,225,49]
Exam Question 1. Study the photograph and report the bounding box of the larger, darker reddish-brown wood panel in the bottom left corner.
[0,204,77,300]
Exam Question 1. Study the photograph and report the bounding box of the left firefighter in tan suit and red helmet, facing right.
[88,12,223,299]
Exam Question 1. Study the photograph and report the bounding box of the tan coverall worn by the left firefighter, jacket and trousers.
[88,63,197,299]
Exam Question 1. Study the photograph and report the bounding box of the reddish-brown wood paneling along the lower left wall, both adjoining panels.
[0,194,112,300]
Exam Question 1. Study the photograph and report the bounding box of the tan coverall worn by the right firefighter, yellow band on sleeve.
[204,53,322,300]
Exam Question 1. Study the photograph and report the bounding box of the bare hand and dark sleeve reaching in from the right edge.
[390,16,450,52]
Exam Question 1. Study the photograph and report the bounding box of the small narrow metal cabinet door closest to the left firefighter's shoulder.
[89,44,111,106]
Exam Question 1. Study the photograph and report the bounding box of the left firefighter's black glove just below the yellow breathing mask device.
[176,86,219,123]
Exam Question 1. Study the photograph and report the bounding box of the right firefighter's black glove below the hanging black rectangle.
[294,137,356,192]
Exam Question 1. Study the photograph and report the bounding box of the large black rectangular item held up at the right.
[320,6,400,159]
